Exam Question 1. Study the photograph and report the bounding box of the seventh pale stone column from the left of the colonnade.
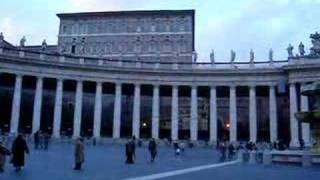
[132,84,141,138]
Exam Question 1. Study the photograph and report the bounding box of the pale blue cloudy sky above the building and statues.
[0,0,320,62]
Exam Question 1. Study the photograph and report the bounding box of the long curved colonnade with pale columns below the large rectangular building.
[0,10,320,147]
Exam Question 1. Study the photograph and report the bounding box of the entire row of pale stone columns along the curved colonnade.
[6,75,310,147]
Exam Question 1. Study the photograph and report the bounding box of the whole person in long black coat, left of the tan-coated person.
[11,134,29,171]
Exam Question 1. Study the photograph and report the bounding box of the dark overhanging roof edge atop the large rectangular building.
[57,9,195,18]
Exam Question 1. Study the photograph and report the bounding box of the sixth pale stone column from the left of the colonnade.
[112,83,122,138]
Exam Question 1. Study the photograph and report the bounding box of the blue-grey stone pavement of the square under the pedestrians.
[0,144,320,180]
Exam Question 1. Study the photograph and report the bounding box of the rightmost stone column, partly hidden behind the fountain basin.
[300,84,311,147]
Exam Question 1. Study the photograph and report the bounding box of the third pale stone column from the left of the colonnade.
[53,79,63,138]
